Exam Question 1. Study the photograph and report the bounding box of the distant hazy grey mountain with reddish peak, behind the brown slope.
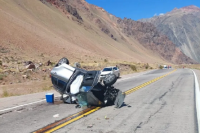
[140,6,200,62]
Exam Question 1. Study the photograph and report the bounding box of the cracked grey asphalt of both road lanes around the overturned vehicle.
[0,69,197,133]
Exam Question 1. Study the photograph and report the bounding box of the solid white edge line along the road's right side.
[192,70,200,133]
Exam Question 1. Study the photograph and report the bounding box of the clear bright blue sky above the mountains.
[86,0,200,20]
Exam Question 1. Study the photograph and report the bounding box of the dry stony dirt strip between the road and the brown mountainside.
[0,62,156,98]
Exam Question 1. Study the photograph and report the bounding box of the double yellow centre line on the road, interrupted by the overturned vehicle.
[33,69,176,133]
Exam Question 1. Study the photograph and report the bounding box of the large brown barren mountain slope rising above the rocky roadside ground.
[0,0,195,63]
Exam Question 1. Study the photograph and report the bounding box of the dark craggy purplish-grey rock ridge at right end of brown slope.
[115,19,193,63]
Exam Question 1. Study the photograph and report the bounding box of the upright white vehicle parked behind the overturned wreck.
[100,66,120,78]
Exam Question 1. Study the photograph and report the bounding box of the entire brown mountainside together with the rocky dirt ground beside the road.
[0,0,196,98]
